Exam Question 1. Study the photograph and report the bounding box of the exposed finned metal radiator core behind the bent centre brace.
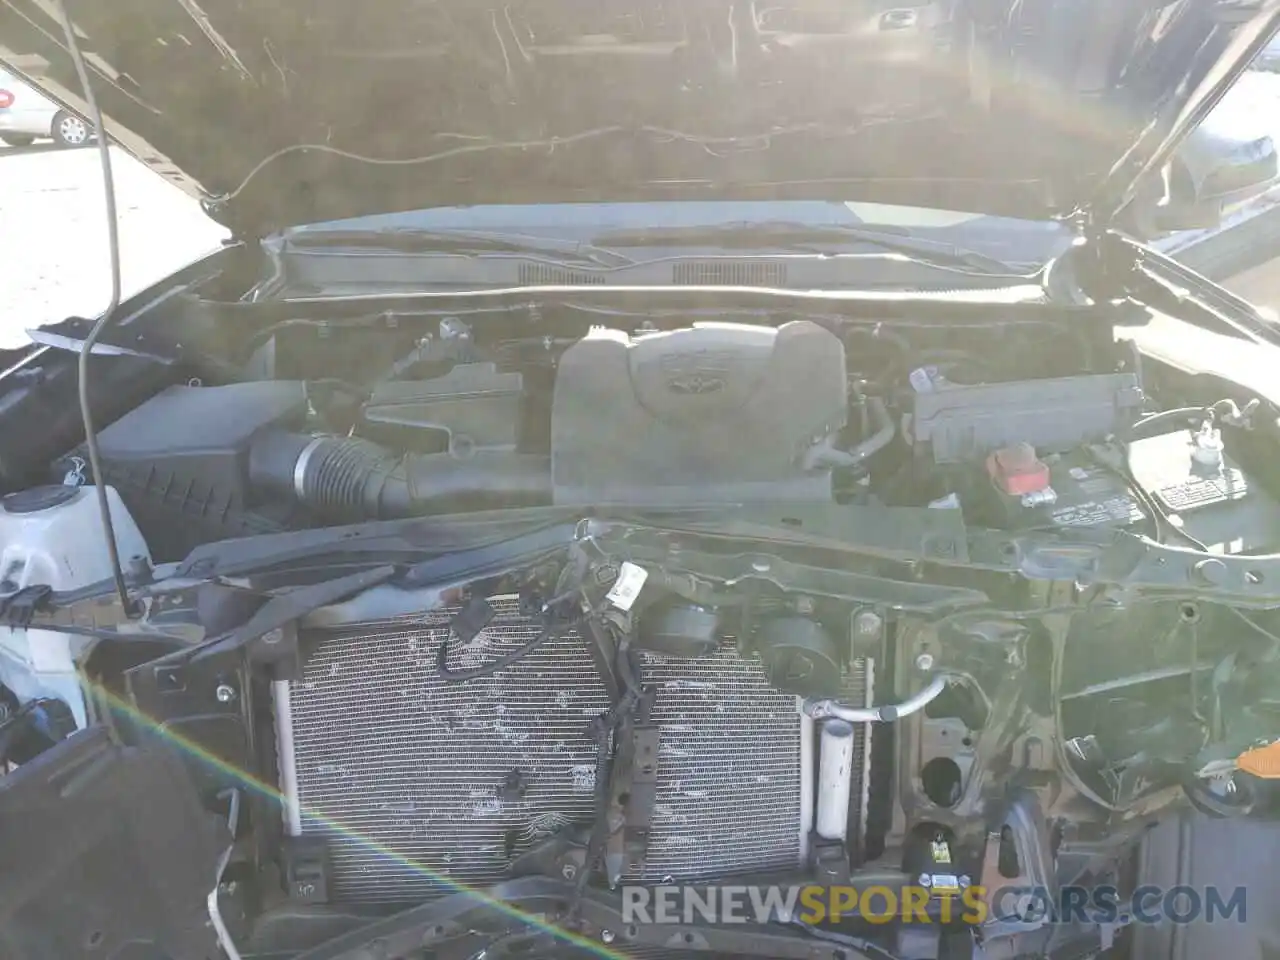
[289,598,865,902]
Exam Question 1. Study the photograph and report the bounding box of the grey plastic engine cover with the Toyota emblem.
[552,320,847,504]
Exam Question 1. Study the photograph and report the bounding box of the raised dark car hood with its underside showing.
[0,0,1280,236]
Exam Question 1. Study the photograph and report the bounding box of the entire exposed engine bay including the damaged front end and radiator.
[0,305,1280,960]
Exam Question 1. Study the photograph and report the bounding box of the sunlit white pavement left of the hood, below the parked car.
[0,140,225,347]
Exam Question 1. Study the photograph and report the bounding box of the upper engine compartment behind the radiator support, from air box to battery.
[49,302,1280,561]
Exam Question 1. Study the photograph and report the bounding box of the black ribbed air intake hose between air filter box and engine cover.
[248,431,552,522]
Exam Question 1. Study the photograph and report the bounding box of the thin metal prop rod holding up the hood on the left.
[55,0,134,617]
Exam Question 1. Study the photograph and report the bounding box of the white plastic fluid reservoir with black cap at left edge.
[0,486,151,728]
